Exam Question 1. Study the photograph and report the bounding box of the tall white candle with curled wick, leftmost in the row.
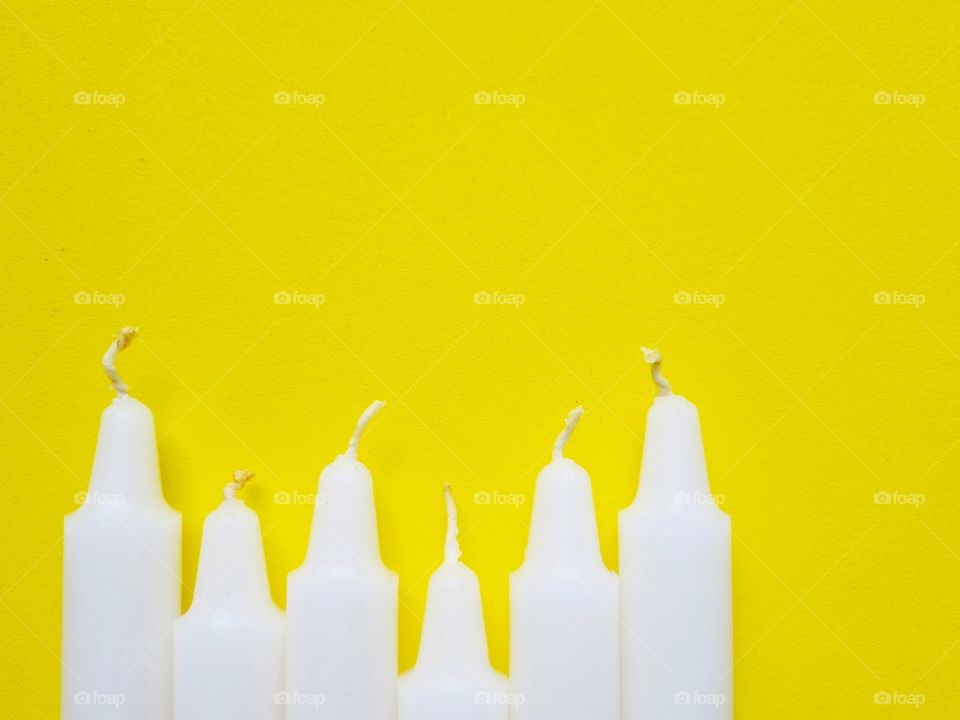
[61,328,180,720]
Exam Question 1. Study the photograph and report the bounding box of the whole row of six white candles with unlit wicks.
[62,328,732,720]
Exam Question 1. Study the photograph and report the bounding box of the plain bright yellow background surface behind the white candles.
[0,0,960,718]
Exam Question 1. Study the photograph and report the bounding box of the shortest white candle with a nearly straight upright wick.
[400,485,509,720]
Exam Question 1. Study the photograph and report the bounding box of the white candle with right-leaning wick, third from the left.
[287,402,398,720]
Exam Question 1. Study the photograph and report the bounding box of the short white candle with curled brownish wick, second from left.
[174,470,284,720]
